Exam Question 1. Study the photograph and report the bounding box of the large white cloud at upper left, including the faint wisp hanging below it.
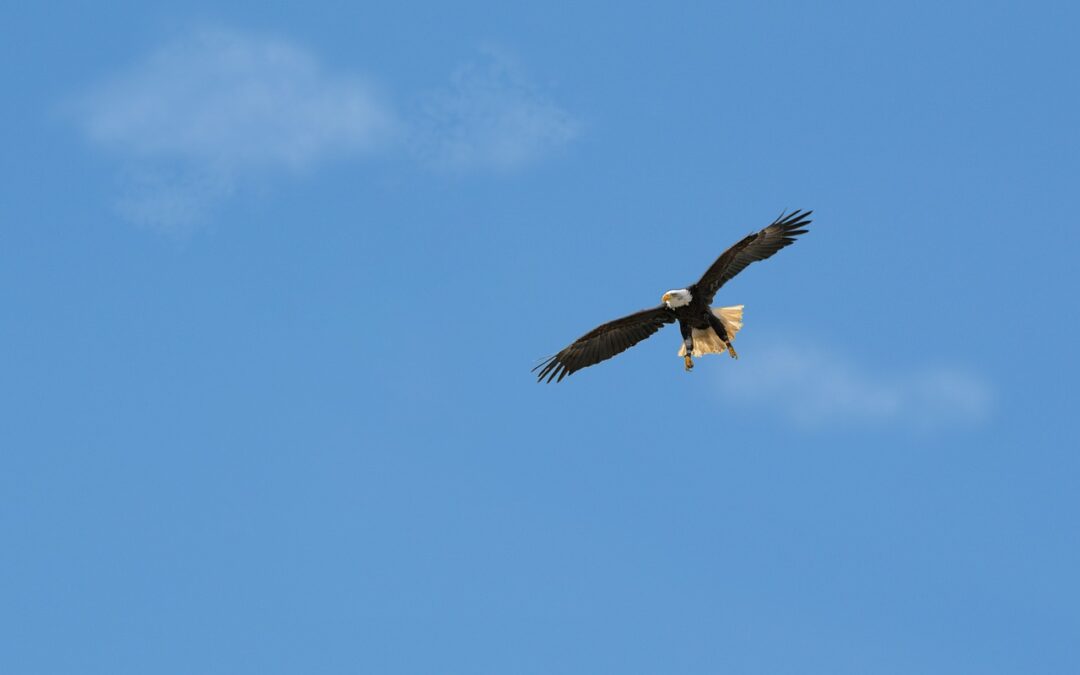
[76,30,399,233]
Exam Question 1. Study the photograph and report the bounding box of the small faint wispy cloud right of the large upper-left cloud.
[413,51,581,171]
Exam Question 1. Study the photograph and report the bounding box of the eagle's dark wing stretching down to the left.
[532,305,675,382]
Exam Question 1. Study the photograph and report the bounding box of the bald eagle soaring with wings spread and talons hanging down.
[532,211,813,382]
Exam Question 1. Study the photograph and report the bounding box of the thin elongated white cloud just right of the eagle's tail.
[721,345,994,431]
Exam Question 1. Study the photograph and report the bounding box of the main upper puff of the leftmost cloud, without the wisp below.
[82,30,394,172]
